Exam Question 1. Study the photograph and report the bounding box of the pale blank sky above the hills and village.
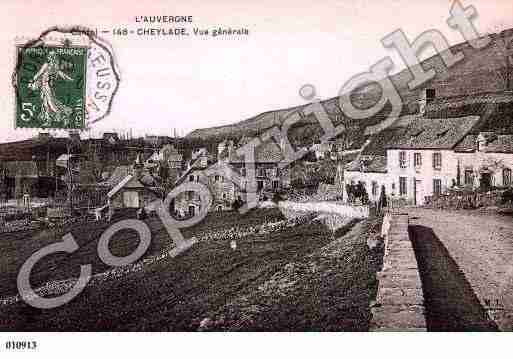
[0,0,513,142]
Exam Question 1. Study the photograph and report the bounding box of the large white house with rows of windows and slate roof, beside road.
[344,116,513,205]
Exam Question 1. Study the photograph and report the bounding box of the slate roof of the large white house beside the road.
[386,116,479,149]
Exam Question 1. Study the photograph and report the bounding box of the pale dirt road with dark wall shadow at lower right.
[408,208,513,331]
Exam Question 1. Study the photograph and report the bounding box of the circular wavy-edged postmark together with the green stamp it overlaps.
[13,27,120,130]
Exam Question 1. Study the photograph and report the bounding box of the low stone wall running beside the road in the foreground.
[371,213,426,331]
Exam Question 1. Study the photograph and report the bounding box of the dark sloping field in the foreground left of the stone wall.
[0,210,375,331]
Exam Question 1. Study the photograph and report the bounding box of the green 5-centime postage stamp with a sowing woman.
[16,46,87,129]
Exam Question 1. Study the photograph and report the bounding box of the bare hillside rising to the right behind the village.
[187,29,513,143]
